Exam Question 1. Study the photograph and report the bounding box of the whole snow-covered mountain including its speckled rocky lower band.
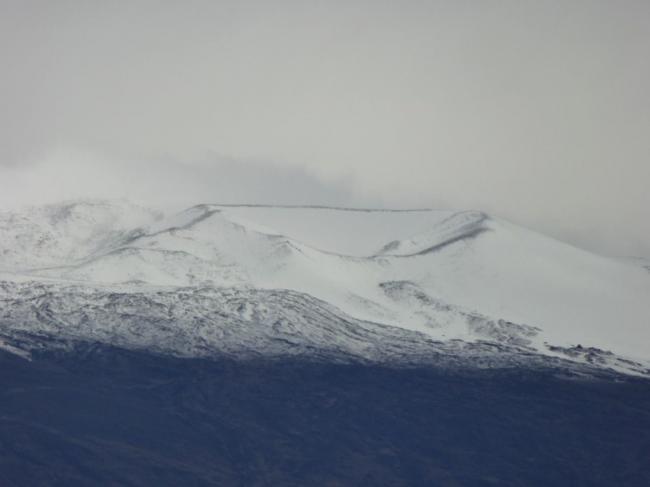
[0,201,650,375]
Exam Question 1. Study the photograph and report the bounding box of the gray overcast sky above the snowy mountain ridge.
[0,0,650,257]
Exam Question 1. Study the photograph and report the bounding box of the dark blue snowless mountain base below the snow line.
[0,347,650,487]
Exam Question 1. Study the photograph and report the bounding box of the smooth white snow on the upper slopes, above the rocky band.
[0,202,650,374]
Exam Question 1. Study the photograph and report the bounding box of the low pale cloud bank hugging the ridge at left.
[0,149,364,210]
